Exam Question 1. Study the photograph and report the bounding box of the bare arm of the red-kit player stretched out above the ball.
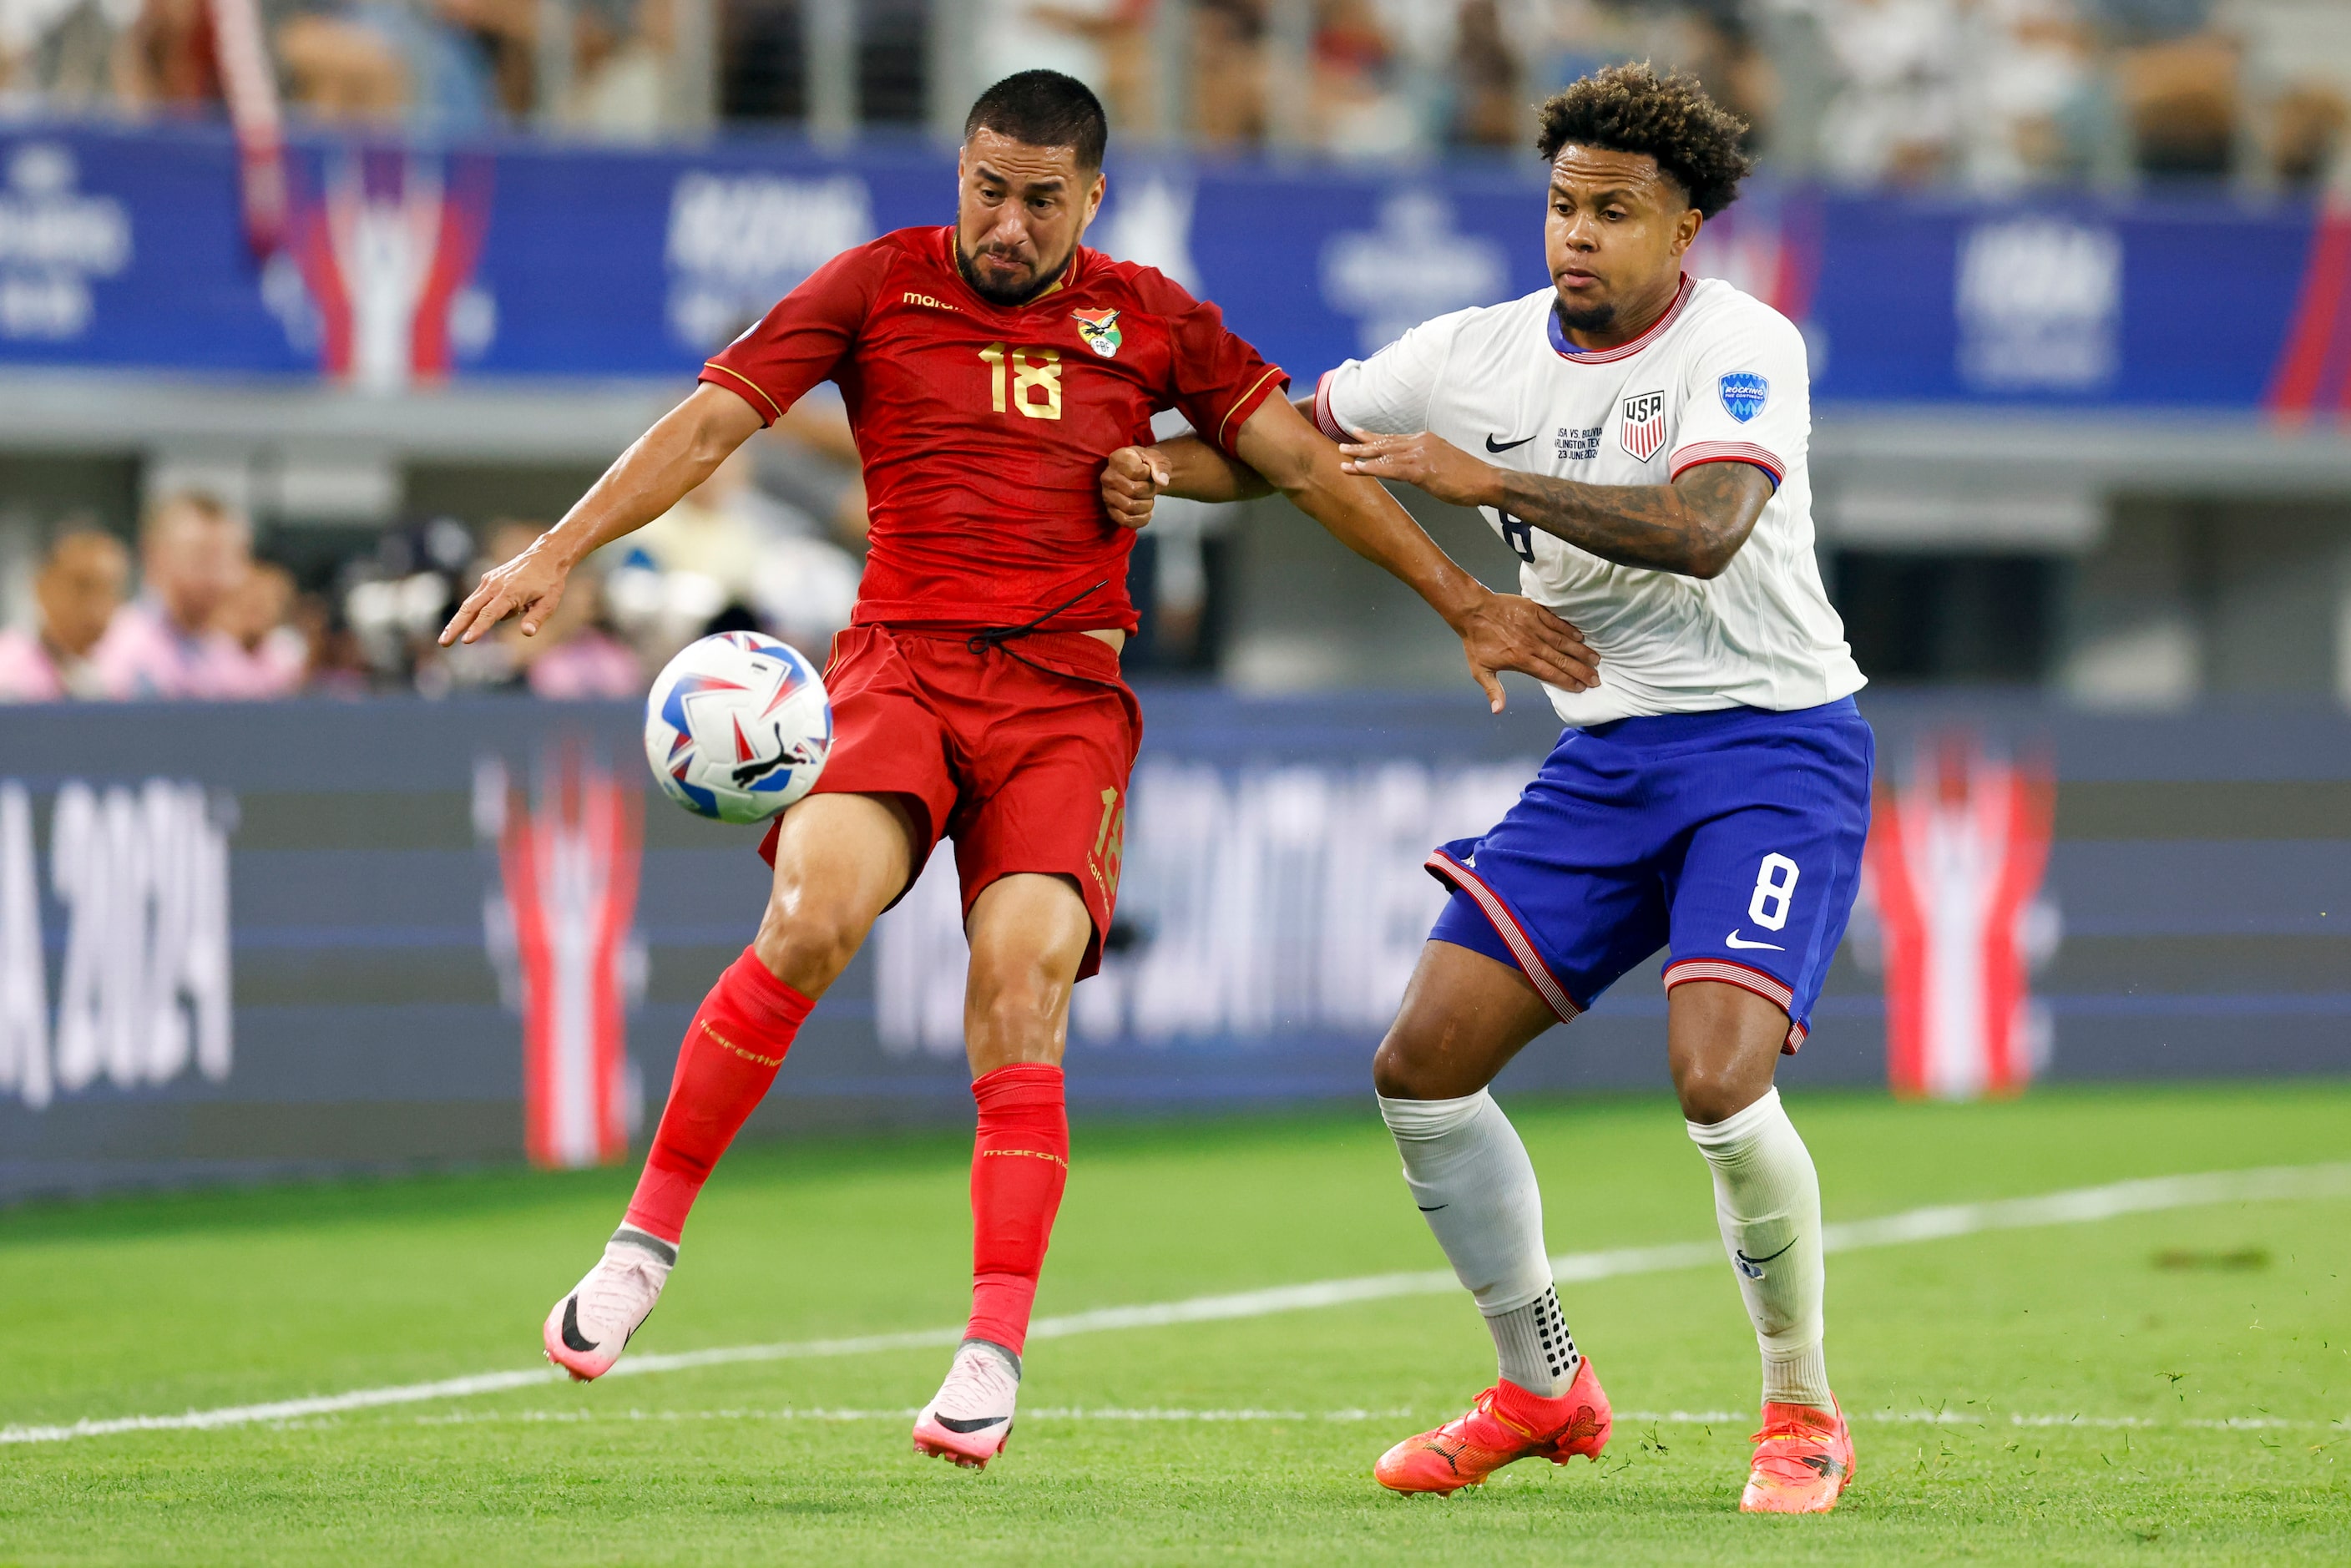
[440,383,761,646]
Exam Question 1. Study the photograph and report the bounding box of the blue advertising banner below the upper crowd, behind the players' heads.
[0,124,2351,414]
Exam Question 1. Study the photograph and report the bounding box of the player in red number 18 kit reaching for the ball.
[442,70,1594,1467]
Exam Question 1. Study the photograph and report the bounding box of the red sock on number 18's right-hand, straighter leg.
[964,1063,1069,1357]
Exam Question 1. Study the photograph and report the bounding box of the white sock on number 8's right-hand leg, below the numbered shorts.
[1688,1089,1832,1410]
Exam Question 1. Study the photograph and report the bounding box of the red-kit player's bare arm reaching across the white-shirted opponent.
[1234,397,1599,712]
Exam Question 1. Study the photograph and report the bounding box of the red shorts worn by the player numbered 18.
[760,625,1143,980]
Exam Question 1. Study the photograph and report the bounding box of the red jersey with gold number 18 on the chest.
[700,228,1288,632]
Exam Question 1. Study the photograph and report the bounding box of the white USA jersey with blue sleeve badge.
[1314,277,1864,724]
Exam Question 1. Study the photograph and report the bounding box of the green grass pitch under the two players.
[0,1084,2351,1563]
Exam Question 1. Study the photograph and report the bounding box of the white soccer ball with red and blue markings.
[645,632,832,822]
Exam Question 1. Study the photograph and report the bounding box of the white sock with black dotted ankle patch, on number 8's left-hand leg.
[1380,1089,1580,1399]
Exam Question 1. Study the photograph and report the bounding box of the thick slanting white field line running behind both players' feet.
[0,1164,2351,1444]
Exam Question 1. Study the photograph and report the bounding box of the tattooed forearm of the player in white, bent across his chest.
[1340,430,1772,579]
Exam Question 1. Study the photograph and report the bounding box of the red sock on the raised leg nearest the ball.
[628,948,816,1246]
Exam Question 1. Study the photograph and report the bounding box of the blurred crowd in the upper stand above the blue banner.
[0,0,2351,184]
